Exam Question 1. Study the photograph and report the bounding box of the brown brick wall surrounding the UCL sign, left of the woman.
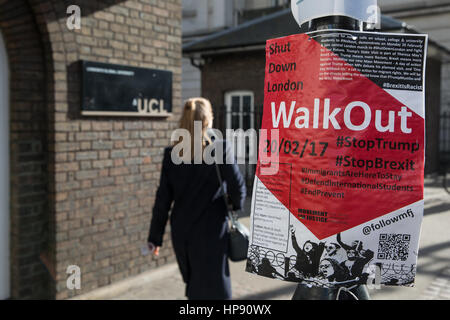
[0,0,182,299]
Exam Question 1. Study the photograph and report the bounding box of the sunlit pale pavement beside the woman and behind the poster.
[76,178,450,300]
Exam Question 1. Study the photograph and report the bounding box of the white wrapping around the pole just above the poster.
[291,0,380,26]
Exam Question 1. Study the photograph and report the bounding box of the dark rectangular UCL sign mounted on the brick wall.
[81,61,172,117]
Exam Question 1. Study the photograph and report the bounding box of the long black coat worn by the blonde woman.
[148,145,246,299]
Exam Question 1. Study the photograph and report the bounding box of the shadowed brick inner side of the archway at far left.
[0,0,51,298]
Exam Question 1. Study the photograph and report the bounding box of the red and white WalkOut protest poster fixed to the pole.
[246,30,428,288]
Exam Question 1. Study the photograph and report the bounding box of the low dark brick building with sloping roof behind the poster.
[183,9,449,175]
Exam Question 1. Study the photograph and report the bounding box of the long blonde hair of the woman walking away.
[175,97,213,157]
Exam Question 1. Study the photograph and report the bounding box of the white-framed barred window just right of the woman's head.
[225,91,255,131]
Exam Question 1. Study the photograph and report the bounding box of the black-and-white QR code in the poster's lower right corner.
[378,233,411,261]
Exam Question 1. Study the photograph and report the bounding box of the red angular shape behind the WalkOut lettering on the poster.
[257,34,424,239]
